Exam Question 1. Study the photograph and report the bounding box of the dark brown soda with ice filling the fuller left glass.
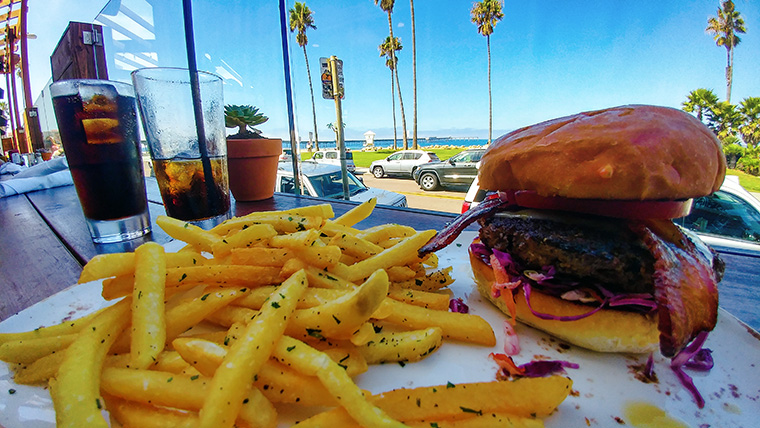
[53,94,148,220]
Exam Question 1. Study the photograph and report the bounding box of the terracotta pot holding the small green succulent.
[227,138,282,201]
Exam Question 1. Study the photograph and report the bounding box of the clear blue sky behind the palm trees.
[29,0,760,140]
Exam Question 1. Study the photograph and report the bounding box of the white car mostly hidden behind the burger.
[462,175,760,253]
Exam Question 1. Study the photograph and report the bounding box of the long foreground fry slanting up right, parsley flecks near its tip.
[198,272,307,428]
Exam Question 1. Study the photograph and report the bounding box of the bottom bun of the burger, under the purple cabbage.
[470,252,659,353]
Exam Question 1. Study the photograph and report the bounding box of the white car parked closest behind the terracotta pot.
[274,161,407,207]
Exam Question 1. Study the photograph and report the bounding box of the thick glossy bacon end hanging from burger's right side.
[633,221,719,358]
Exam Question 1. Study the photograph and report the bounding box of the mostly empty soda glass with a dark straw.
[132,67,230,227]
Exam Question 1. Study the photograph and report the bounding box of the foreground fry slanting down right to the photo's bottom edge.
[273,336,405,428]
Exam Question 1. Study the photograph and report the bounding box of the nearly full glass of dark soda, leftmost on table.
[50,79,150,243]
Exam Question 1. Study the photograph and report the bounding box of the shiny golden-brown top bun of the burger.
[478,105,726,201]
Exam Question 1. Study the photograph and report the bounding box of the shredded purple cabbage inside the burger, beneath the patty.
[470,242,657,321]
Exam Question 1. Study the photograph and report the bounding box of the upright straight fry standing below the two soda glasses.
[130,242,166,369]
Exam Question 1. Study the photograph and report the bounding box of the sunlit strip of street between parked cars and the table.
[356,168,466,214]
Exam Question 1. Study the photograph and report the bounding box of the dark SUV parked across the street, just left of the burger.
[413,149,486,191]
